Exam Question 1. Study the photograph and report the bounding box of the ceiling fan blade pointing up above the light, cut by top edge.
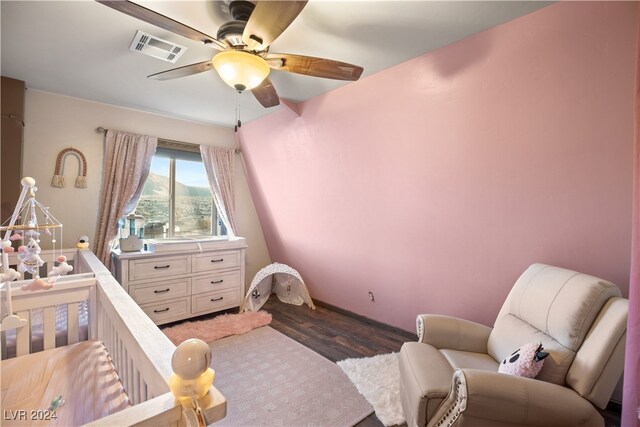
[242,0,307,50]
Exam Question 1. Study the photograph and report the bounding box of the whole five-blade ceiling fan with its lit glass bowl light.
[96,0,363,108]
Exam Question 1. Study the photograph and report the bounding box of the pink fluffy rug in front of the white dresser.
[162,311,271,345]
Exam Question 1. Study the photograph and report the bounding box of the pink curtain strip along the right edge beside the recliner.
[622,14,640,427]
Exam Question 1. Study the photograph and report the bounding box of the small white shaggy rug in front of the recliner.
[338,353,406,426]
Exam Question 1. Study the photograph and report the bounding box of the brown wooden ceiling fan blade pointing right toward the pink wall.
[265,53,363,81]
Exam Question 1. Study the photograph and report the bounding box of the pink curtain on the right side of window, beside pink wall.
[200,145,238,236]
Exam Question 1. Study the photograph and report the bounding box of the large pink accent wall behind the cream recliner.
[241,2,638,330]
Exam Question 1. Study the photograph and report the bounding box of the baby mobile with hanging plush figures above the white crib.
[0,177,73,330]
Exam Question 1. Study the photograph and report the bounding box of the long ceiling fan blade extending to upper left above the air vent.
[96,0,227,50]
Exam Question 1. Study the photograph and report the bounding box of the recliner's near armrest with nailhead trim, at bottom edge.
[427,369,604,427]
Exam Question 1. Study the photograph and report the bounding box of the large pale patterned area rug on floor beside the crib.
[209,326,373,427]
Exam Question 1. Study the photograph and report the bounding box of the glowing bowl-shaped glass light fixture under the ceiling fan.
[211,50,270,92]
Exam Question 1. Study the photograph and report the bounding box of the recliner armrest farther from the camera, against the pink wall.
[416,314,491,354]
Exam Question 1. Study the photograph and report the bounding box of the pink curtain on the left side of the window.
[95,130,158,269]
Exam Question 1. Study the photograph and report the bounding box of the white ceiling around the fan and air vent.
[0,0,549,126]
